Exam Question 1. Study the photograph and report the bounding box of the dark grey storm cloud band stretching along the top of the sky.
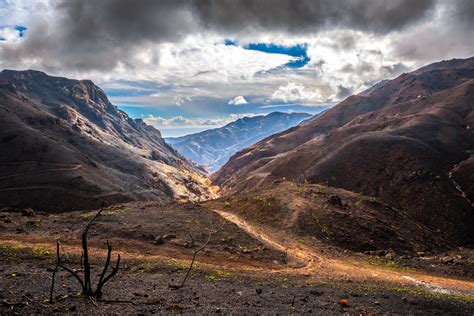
[0,0,474,71]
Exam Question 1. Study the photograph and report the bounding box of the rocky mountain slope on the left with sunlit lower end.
[0,70,209,211]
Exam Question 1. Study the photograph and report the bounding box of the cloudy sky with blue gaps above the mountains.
[0,0,474,136]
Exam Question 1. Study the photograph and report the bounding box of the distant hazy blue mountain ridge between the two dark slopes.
[165,112,311,172]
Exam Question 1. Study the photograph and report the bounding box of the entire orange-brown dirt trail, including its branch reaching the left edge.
[0,205,474,298]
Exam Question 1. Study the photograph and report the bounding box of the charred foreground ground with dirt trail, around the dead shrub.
[0,202,474,315]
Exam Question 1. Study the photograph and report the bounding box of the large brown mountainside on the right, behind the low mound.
[214,58,474,243]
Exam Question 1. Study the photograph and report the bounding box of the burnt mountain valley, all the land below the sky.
[0,58,474,315]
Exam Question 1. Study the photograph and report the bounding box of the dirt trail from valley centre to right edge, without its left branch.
[212,209,474,297]
